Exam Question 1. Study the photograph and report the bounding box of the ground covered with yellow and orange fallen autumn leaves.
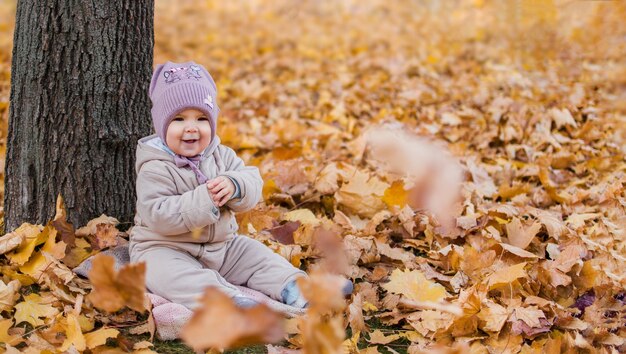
[0,0,626,353]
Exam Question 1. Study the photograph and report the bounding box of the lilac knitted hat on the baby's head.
[149,61,220,142]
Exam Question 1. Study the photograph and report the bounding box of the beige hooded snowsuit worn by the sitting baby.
[130,135,305,309]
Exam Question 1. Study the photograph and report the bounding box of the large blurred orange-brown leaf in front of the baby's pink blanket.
[181,287,283,350]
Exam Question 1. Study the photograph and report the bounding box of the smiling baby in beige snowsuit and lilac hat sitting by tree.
[130,62,314,310]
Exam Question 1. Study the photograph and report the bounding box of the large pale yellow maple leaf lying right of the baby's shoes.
[383,269,448,302]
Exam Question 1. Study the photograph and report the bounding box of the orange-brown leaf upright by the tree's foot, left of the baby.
[89,254,146,312]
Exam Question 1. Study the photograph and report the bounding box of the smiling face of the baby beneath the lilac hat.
[165,108,211,157]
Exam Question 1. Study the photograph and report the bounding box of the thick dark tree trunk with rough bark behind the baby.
[4,0,154,231]
